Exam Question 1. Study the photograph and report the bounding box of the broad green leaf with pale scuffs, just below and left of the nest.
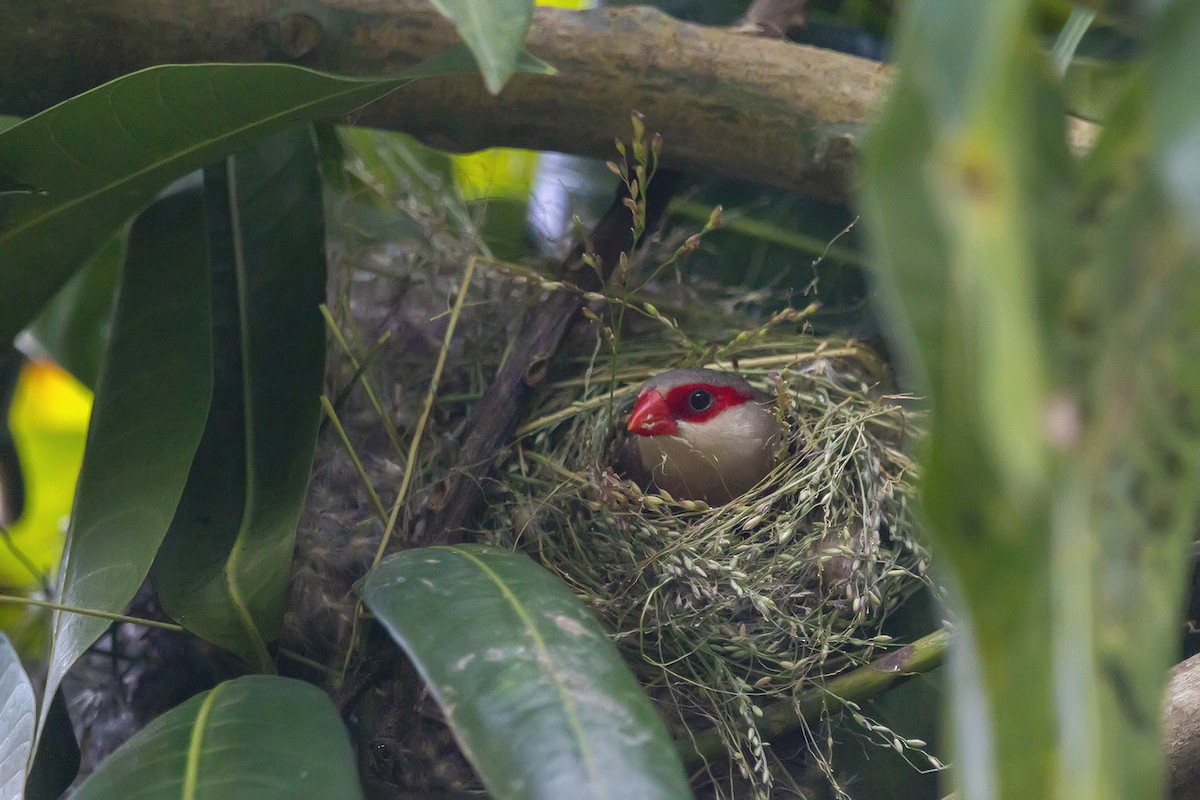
[359,546,691,800]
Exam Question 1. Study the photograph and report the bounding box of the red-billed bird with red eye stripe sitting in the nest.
[623,369,780,505]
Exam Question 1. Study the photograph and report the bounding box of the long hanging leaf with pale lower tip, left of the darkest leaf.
[42,192,212,738]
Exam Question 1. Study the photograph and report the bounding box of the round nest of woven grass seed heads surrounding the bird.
[478,326,926,793]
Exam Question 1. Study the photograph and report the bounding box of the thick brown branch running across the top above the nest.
[0,0,887,200]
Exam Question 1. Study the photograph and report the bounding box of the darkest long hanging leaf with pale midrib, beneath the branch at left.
[155,126,325,669]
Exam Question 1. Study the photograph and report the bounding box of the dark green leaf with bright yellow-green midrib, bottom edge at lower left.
[71,675,362,800]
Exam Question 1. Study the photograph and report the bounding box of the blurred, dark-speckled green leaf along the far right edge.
[1052,4,1200,798]
